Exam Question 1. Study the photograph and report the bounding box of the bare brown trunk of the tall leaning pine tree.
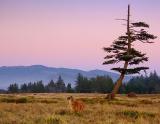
[106,5,131,100]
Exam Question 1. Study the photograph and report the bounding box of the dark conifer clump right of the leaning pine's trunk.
[120,72,160,94]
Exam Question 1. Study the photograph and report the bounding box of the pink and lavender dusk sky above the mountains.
[0,0,160,74]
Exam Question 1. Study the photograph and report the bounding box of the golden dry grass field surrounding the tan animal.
[0,94,160,124]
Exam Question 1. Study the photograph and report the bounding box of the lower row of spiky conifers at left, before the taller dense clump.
[8,76,73,93]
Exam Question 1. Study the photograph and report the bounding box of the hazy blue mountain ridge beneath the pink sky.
[0,65,130,89]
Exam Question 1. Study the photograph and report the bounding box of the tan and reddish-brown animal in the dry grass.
[67,96,85,112]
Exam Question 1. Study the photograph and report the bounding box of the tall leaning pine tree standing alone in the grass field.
[103,5,156,99]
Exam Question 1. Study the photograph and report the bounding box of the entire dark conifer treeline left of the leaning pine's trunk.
[7,74,114,93]
